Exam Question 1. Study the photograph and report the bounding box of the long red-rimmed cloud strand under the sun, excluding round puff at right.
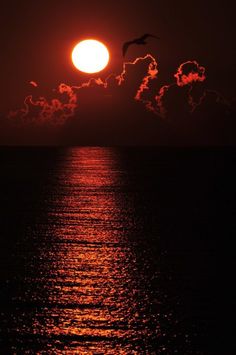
[8,54,158,125]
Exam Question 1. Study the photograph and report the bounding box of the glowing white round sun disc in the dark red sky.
[71,39,110,74]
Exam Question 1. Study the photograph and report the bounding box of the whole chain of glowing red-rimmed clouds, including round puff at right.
[8,54,210,125]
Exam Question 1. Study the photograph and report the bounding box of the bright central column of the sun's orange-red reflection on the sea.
[26,148,160,354]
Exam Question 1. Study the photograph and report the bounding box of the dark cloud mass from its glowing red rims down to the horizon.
[4,54,236,145]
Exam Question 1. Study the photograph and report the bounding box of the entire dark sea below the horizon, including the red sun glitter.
[0,147,236,355]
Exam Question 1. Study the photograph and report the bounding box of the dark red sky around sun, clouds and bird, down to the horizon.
[0,0,236,144]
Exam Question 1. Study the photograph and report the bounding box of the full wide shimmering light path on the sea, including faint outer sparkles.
[0,148,164,354]
